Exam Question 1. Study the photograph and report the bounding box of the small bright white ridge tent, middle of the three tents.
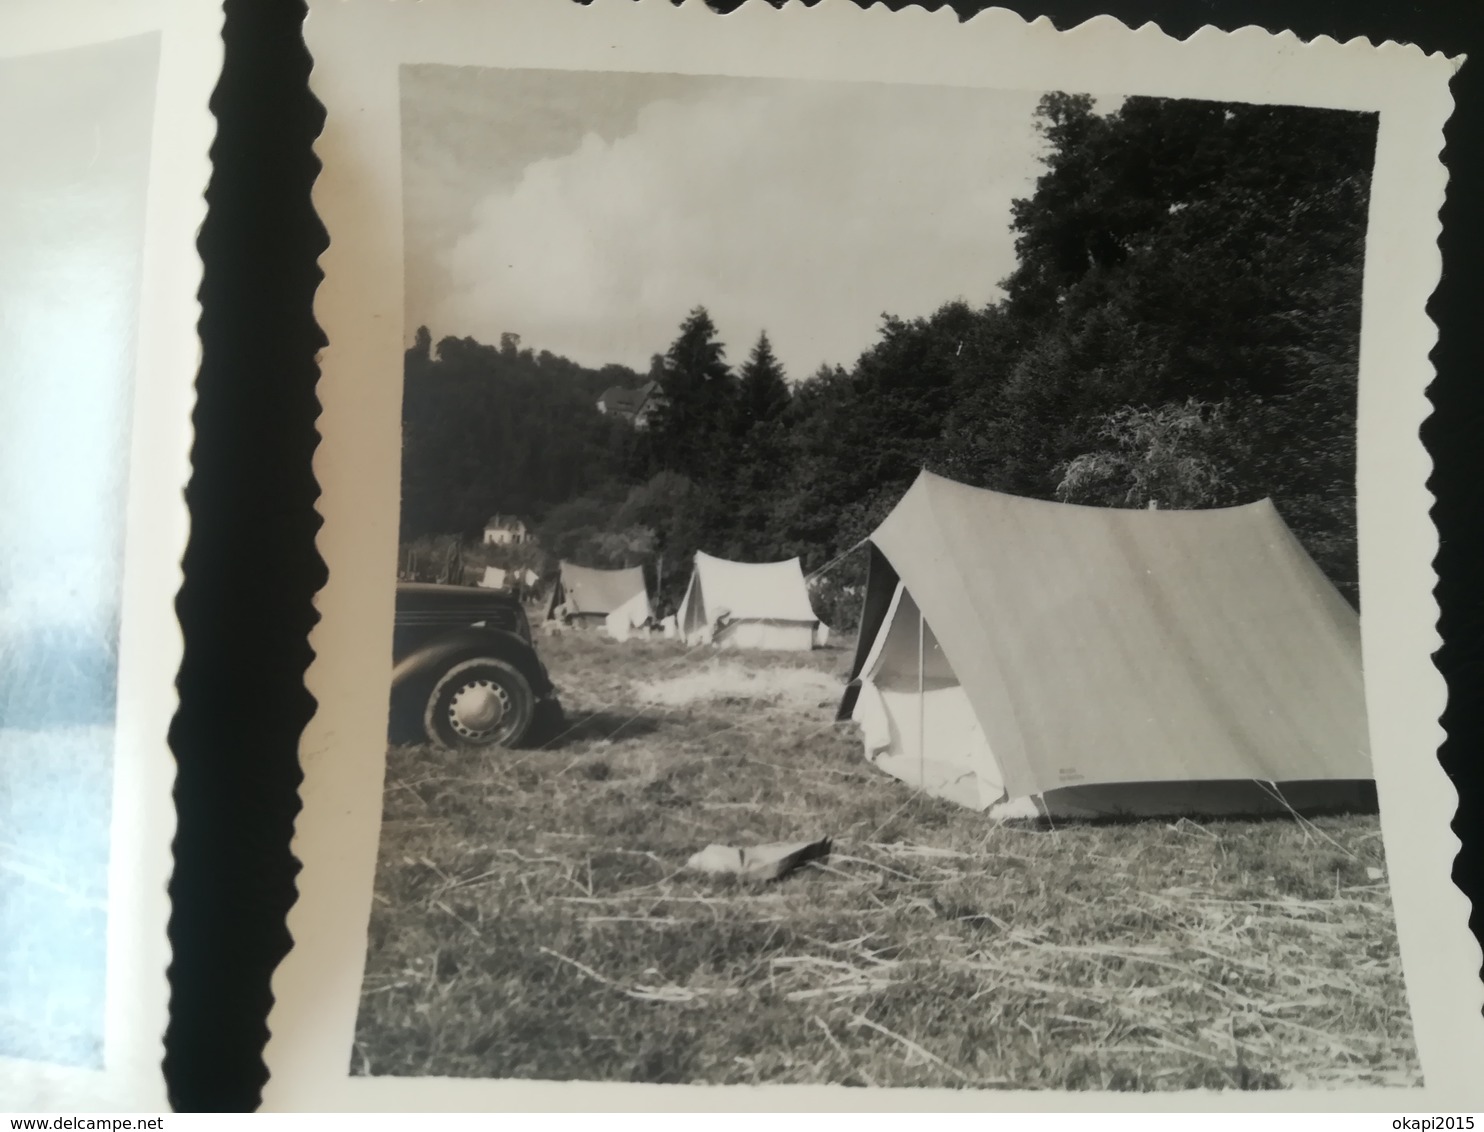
[677,552,819,650]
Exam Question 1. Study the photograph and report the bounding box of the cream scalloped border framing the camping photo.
[264,0,1484,1113]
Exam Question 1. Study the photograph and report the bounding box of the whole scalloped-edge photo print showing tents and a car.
[266,3,1484,1108]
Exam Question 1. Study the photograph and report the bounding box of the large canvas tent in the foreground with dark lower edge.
[840,472,1374,816]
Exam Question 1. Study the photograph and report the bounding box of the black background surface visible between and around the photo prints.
[165,0,1484,1111]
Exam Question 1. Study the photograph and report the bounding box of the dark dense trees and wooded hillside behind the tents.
[404,93,1376,616]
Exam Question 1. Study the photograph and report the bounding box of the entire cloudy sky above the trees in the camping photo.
[402,65,1042,378]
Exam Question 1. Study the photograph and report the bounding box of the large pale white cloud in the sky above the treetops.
[430,83,1039,377]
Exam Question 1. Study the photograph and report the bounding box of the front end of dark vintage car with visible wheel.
[392,582,561,748]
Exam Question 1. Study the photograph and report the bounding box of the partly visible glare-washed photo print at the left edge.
[0,0,220,1110]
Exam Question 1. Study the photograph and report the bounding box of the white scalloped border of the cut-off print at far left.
[0,0,223,1111]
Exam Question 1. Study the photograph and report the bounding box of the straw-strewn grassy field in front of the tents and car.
[352,635,1420,1090]
